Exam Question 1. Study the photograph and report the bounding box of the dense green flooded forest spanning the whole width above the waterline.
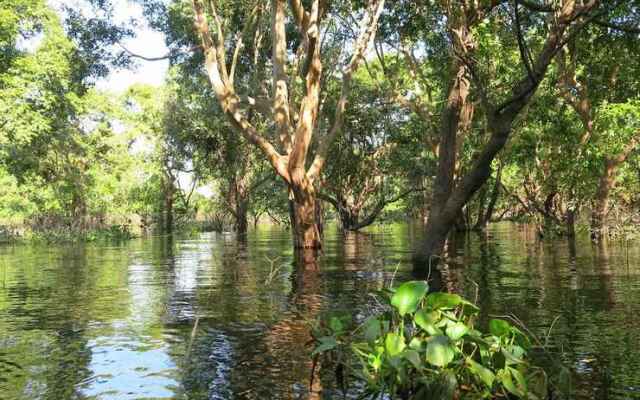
[0,0,640,253]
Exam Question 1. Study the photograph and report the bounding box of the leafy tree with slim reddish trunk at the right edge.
[557,24,640,239]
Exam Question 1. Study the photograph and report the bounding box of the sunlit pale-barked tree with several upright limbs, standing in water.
[188,0,384,263]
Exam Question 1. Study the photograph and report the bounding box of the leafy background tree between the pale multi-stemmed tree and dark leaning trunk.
[319,65,422,231]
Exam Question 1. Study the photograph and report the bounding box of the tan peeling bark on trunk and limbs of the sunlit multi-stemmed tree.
[193,0,384,262]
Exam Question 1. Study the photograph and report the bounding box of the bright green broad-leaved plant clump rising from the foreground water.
[313,281,547,399]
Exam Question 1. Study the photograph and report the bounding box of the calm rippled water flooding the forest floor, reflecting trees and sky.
[0,224,640,400]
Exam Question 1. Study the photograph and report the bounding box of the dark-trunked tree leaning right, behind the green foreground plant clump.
[418,1,606,270]
